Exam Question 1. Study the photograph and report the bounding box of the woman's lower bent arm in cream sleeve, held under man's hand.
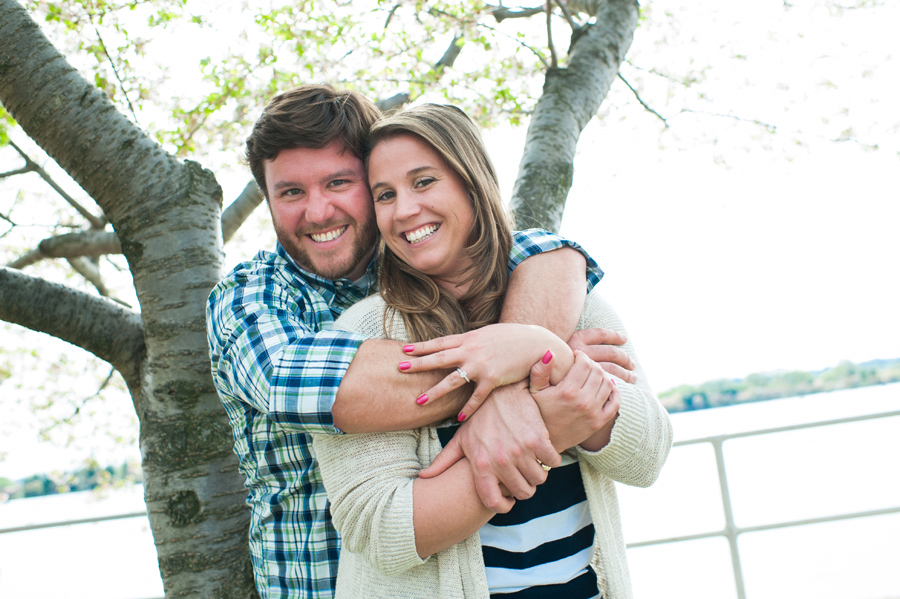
[312,428,506,574]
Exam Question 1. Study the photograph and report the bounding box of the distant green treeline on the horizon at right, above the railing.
[659,358,900,413]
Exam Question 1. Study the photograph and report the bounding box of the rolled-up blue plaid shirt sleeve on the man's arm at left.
[207,272,365,434]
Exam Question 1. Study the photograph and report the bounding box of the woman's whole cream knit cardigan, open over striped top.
[312,291,672,599]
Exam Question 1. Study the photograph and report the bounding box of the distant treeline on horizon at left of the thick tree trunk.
[0,463,143,503]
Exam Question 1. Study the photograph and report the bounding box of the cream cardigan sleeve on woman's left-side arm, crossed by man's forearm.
[312,296,425,574]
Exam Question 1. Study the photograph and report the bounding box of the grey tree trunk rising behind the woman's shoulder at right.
[510,0,638,231]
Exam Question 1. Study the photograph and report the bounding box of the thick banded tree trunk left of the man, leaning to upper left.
[0,0,255,598]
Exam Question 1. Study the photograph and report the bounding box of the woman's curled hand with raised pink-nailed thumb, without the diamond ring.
[530,351,620,451]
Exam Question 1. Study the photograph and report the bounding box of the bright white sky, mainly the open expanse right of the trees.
[0,0,900,477]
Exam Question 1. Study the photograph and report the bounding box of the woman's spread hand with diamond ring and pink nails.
[399,323,572,421]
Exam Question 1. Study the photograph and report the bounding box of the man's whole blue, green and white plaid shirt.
[206,229,603,599]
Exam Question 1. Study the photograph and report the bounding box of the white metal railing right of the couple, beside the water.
[628,410,900,599]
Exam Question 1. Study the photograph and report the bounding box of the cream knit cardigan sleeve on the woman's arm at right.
[577,291,672,487]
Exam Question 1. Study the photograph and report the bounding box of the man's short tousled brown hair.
[246,84,381,199]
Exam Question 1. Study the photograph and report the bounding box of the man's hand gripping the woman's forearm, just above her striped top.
[419,383,561,512]
